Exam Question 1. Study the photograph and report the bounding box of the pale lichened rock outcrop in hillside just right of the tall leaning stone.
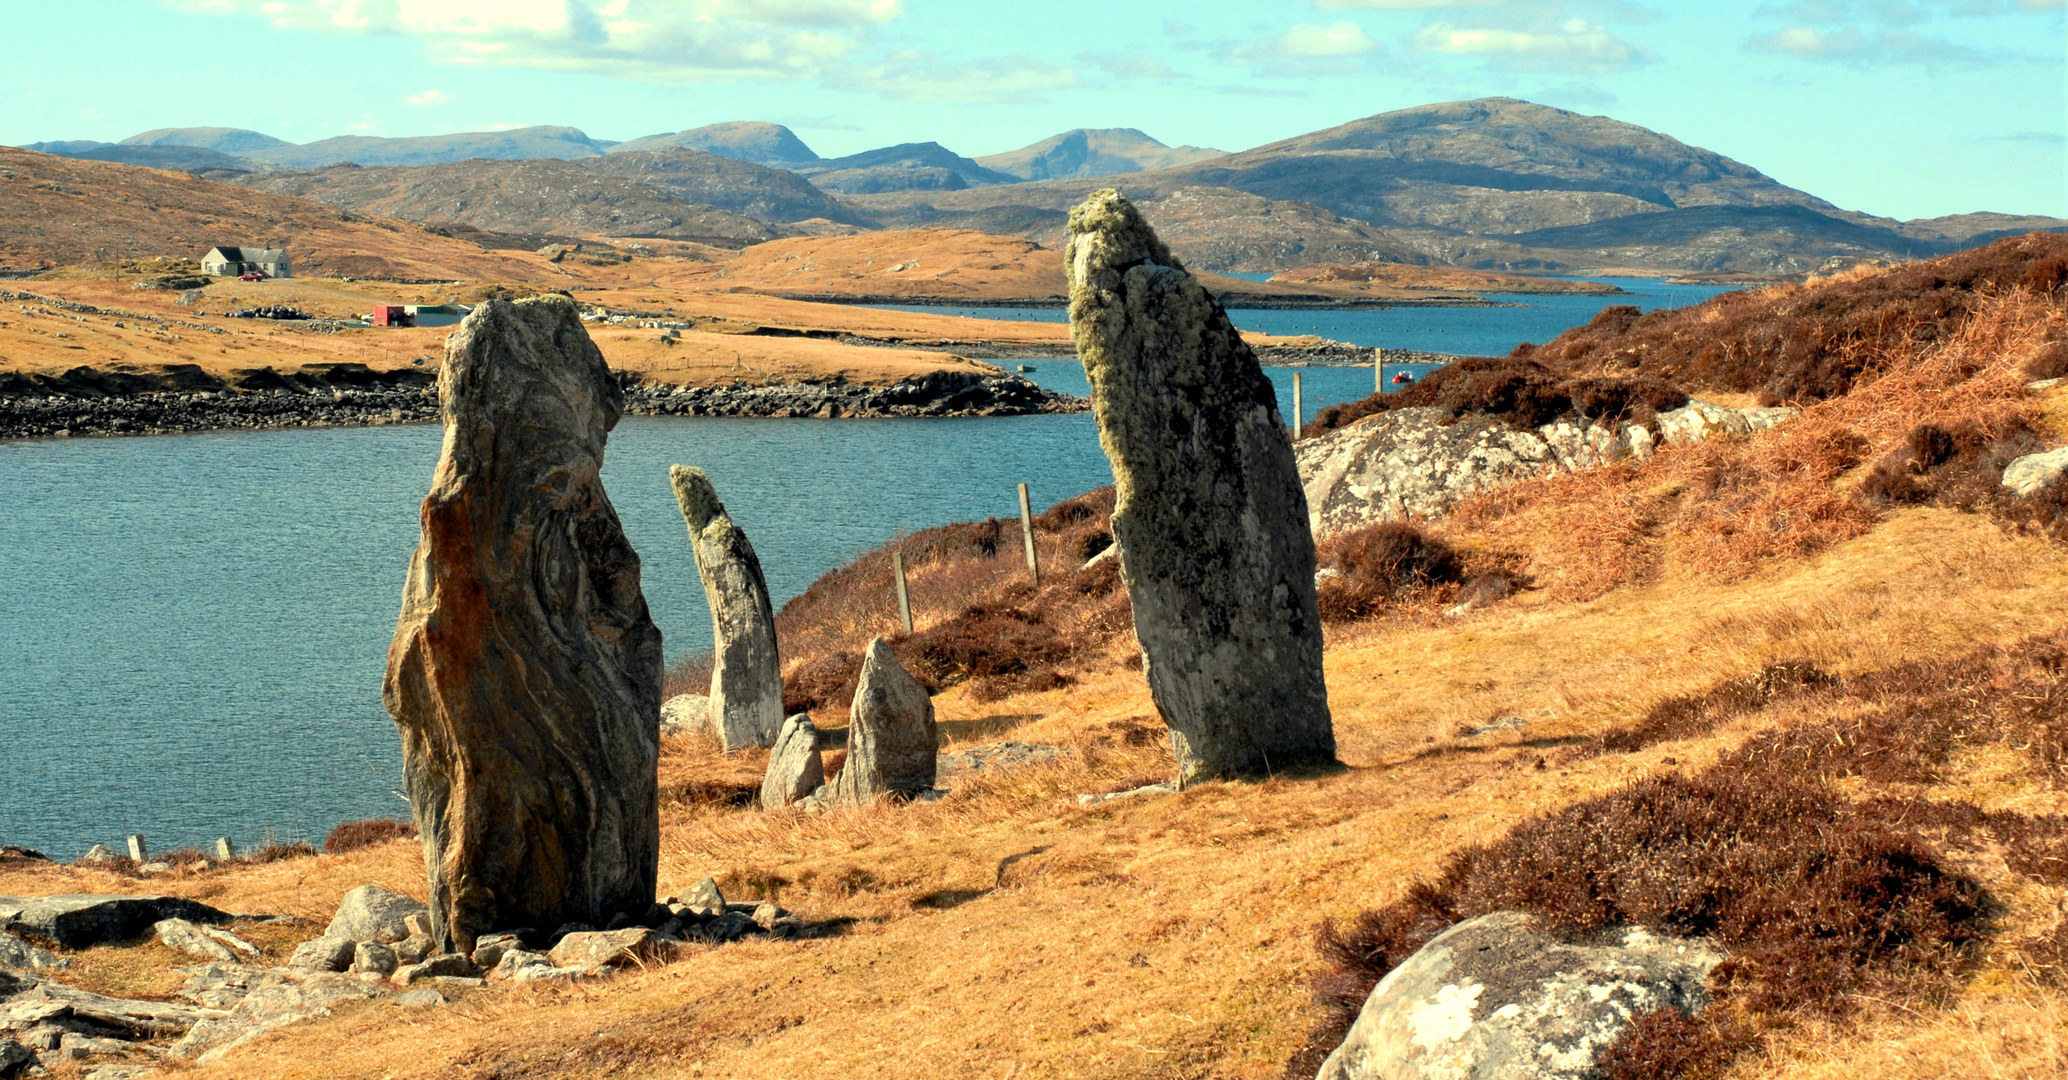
[1297,401,1797,538]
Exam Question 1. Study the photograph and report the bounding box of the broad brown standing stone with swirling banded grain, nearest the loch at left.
[381,296,662,952]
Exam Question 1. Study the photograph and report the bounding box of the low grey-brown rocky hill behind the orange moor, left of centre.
[228,159,776,248]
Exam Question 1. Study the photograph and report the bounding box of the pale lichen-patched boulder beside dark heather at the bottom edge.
[1317,912,1723,1080]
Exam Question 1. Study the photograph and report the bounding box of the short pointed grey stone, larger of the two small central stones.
[831,637,941,803]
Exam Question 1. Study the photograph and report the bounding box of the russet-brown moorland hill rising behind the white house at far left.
[0,147,538,279]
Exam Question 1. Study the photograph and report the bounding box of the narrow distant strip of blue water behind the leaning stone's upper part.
[868,275,1729,356]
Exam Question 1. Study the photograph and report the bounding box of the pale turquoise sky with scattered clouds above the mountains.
[0,0,2068,219]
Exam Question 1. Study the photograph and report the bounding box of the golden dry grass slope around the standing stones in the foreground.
[0,237,2068,1078]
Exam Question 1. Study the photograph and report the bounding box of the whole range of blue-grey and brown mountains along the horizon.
[25,97,2068,275]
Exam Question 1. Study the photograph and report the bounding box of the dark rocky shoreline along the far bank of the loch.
[0,370,1086,439]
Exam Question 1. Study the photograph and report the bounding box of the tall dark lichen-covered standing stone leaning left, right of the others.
[1065,188,1336,782]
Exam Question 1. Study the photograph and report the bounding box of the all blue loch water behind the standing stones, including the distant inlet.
[0,286,1714,859]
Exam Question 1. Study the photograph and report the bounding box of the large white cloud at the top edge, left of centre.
[170,0,904,83]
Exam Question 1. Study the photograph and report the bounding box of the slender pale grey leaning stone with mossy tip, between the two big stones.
[668,466,782,753]
